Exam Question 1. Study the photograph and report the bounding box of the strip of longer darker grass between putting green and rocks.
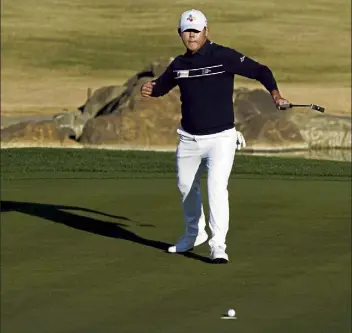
[1,148,351,179]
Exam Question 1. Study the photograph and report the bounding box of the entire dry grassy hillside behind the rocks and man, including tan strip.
[1,0,351,115]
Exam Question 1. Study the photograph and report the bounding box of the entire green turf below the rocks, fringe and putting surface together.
[1,149,351,333]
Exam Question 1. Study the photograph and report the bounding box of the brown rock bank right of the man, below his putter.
[234,89,351,149]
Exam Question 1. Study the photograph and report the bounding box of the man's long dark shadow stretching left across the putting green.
[0,201,209,262]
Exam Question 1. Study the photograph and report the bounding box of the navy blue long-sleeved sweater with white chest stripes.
[152,40,277,135]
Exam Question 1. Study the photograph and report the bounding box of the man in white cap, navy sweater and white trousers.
[141,9,289,263]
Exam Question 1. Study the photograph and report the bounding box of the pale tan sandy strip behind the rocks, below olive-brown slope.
[1,72,351,121]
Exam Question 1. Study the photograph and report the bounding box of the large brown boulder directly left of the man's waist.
[79,89,180,146]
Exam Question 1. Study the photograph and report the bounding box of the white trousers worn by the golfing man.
[176,128,237,250]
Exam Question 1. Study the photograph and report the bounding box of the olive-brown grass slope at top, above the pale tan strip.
[1,0,351,86]
